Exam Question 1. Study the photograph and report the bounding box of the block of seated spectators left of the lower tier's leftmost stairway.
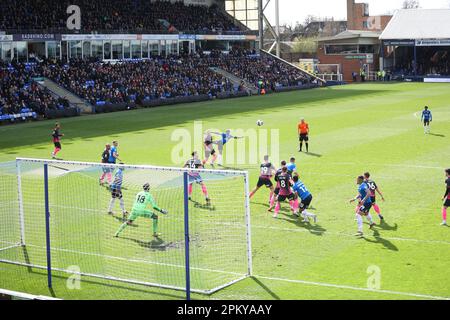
[0,61,68,118]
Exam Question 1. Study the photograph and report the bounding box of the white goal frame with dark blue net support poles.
[0,158,253,299]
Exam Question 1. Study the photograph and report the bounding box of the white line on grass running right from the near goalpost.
[254,275,450,300]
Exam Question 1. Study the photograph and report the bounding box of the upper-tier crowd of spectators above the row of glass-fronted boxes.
[0,0,240,33]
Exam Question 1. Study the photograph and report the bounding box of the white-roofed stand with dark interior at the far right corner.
[380,9,450,82]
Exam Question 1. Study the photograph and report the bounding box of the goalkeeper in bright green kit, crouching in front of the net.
[114,183,167,238]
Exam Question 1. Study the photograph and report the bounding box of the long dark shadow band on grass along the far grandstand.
[0,89,386,149]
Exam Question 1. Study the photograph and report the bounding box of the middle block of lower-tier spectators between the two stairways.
[44,56,235,105]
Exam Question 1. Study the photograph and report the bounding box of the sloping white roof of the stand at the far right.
[380,9,450,40]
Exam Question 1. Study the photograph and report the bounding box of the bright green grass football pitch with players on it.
[0,83,450,299]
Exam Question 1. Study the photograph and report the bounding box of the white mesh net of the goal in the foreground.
[0,159,251,294]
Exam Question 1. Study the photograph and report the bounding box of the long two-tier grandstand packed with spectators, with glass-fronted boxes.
[0,0,316,123]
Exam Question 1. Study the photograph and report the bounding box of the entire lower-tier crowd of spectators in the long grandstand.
[0,50,311,123]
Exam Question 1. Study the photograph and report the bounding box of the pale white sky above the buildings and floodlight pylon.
[266,0,450,24]
